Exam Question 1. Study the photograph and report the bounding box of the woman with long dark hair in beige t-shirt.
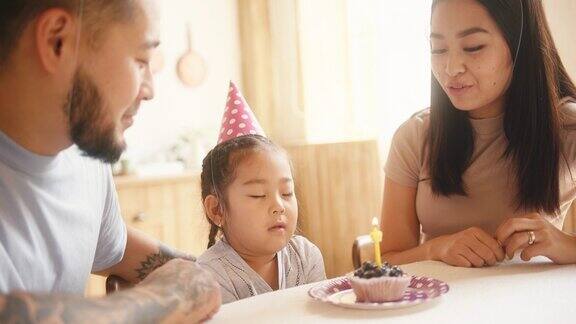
[381,0,576,267]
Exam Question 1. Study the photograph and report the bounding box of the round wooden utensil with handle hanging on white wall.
[176,25,206,87]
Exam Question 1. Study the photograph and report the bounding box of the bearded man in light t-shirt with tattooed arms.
[0,0,220,323]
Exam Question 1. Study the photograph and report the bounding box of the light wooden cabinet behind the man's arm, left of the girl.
[86,174,209,296]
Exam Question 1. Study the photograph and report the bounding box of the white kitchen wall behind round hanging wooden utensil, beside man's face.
[125,0,241,161]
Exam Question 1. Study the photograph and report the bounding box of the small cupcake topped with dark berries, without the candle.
[350,262,412,303]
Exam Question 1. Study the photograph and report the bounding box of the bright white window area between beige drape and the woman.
[298,0,431,146]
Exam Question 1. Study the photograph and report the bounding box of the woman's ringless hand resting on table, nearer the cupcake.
[428,227,504,268]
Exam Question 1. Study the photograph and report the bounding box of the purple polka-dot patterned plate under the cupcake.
[308,276,450,309]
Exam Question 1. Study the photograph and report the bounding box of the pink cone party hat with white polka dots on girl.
[218,81,266,144]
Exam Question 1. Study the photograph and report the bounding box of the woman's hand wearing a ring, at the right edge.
[496,213,576,264]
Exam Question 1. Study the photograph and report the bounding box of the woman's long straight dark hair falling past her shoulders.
[426,0,576,214]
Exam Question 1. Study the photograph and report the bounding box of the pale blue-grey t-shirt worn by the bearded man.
[0,131,126,294]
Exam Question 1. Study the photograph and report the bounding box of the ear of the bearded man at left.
[34,8,81,73]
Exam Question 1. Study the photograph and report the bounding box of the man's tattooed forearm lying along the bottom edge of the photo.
[0,260,220,323]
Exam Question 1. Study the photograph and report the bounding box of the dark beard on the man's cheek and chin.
[64,69,126,163]
